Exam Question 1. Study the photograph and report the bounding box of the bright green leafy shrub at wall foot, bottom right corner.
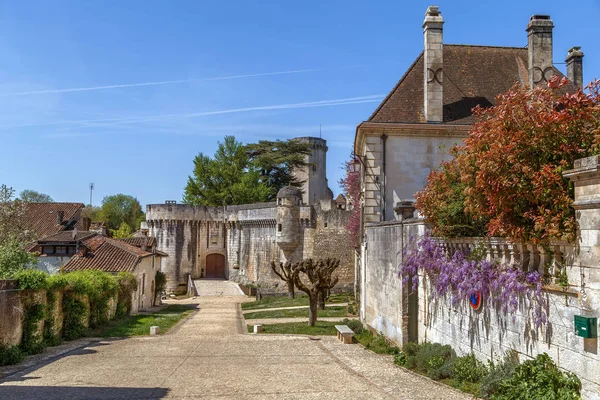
[491,353,581,400]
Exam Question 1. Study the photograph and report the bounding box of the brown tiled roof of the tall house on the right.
[369,45,577,124]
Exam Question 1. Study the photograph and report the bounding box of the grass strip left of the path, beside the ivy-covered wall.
[90,304,193,337]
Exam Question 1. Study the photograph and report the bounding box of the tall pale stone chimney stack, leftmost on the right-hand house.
[423,6,444,122]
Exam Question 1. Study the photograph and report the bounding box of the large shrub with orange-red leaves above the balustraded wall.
[416,79,600,242]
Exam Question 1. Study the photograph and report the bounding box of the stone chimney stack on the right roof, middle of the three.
[527,15,554,88]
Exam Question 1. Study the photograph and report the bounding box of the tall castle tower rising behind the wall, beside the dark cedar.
[294,137,333,205]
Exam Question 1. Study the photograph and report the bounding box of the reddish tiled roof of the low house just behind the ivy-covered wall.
[63,236,153,272]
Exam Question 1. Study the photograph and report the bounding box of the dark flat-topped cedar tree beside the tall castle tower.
[246,139,311,200]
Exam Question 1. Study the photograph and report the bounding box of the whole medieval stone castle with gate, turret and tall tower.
[146,137,354,291]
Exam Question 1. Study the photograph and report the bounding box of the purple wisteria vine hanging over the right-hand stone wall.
[399,236,547,328]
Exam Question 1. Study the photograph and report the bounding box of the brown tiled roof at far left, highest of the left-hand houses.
[25,203,84,238]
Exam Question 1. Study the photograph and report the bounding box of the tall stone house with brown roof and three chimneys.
[354,6,583,223]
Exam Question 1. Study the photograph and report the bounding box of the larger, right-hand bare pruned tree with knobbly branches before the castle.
[292,258,340,326]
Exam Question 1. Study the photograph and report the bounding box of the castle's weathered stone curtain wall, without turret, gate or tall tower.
[146,203,354,292]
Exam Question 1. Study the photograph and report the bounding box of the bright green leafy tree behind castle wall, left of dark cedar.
[183,136,270,206]
